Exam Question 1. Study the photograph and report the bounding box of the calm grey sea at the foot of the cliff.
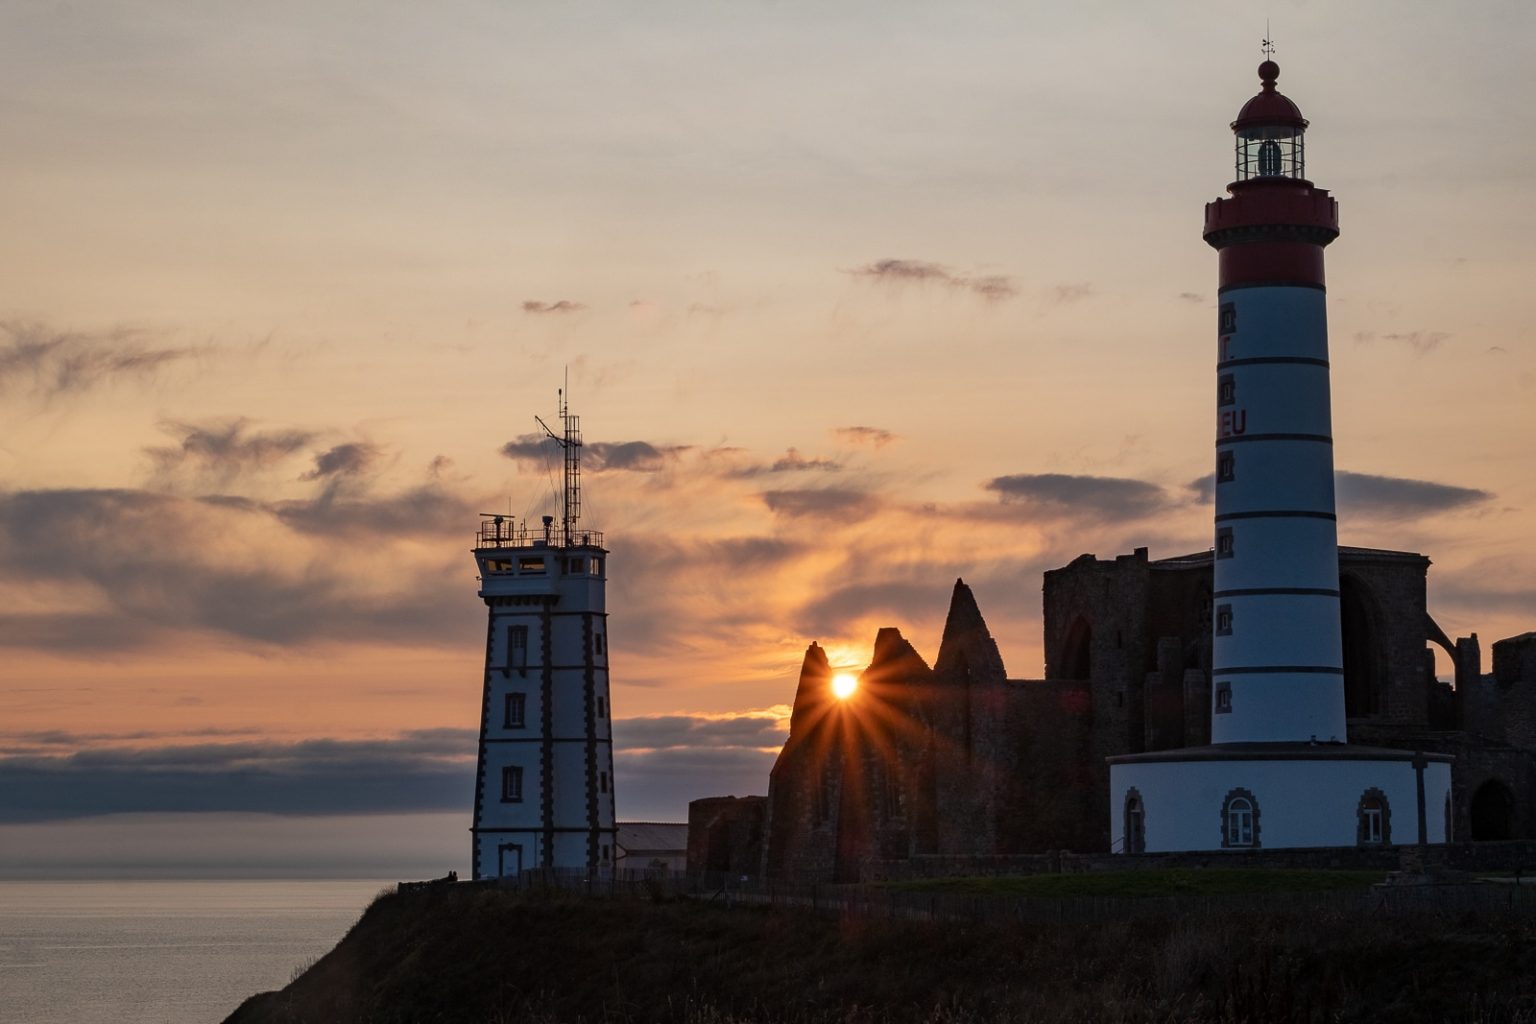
[0,880,390,1024]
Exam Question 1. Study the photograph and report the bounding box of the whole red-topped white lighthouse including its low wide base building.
[1109,57,1452,854]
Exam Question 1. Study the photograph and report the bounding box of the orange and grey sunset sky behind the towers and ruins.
[0,0,1536,875]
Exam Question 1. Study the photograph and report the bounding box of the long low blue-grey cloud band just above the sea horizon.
[0,711,785,823]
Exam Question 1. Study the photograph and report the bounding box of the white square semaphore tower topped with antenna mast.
[470,391,614,878]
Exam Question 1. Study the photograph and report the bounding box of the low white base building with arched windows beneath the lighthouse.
[1109,743,1452,854]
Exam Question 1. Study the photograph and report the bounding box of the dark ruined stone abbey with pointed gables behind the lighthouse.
[697,548,1536,881]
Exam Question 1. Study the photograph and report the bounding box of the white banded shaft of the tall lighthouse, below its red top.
[1210,286,1347,743]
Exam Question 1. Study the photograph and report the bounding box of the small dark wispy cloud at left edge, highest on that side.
[0,321,195,399]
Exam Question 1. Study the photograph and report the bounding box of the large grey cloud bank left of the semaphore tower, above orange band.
[0,490,473,652]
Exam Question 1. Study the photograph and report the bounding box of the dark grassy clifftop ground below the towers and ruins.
[229,886,1536,1024]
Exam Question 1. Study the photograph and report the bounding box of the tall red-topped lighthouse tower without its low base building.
[1204,60,1344,743]
